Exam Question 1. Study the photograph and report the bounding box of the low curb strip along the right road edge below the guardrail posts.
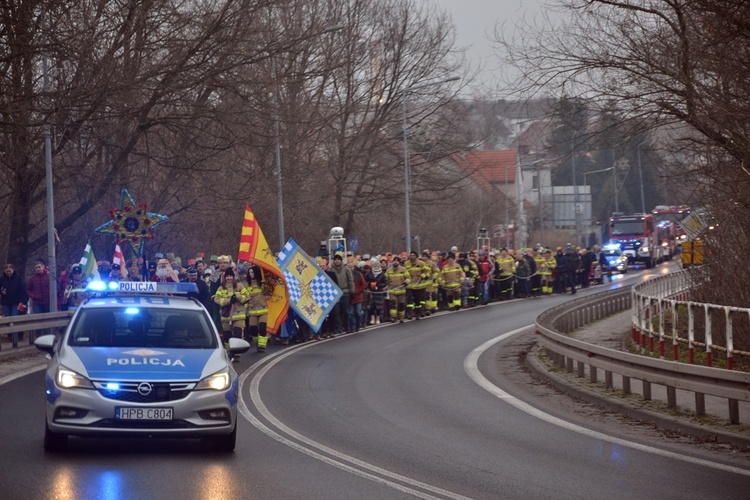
[525,347,750,449]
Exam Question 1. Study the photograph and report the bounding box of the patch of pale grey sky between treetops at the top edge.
[423,0,545,91]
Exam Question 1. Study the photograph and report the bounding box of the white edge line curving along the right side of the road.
[464,325,750,476]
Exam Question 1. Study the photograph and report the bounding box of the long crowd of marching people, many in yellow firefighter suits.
[0,244,611,352]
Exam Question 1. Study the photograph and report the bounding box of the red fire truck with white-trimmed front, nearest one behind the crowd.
[609,213,666,268]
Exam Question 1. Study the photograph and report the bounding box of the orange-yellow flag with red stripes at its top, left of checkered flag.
[237,203,289,335]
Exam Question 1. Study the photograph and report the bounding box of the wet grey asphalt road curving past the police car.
[0,264,750,499]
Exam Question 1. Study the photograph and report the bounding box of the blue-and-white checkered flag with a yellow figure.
[277,238,343,333]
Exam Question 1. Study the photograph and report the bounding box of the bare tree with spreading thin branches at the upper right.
[497,0,750,304]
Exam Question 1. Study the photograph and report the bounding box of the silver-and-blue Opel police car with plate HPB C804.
[35,282,250,451]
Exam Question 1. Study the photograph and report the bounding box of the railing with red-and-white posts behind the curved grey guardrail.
[632,271,750,370]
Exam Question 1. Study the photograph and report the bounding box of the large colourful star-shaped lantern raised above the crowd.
[95,189,168,257]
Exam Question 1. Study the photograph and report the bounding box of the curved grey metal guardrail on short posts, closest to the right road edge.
[536,285,750,424]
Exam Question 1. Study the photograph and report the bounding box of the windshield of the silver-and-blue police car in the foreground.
[69,307,217,349]
